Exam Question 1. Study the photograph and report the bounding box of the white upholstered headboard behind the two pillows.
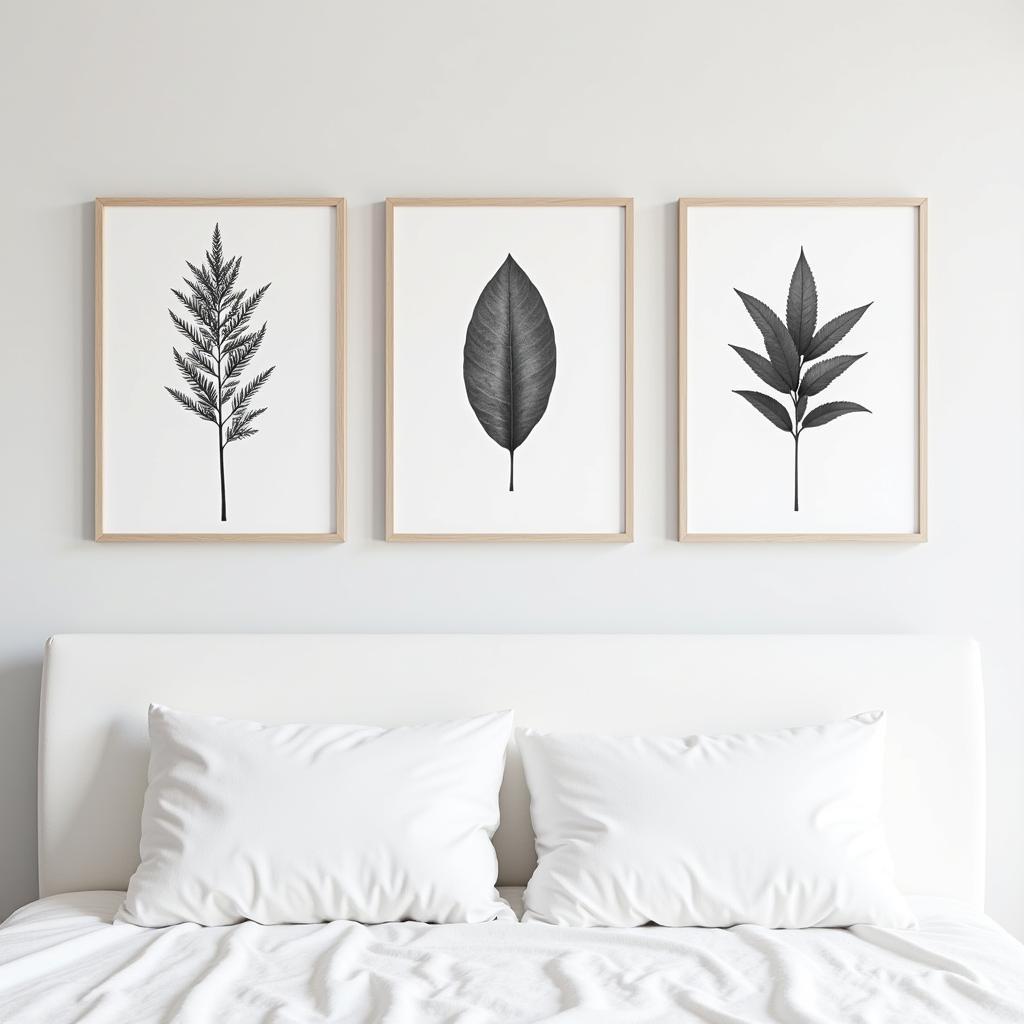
[39,635,985,906]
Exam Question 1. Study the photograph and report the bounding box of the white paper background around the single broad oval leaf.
[394,207,625,534]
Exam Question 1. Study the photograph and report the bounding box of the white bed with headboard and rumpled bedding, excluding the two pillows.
[0,635,1024,1024]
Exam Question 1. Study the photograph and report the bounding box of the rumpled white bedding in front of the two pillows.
[0,891,1024,1024]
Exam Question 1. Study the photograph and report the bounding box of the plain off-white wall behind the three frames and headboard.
[0,0,1024,935]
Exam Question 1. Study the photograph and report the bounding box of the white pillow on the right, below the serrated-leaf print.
[519,712,913,928]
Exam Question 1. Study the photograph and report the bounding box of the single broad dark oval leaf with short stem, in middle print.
[462,253,555,490]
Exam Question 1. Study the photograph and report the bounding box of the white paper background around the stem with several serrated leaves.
[686,207,918,534]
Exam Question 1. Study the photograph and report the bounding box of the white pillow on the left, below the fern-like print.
[118,705,514,926]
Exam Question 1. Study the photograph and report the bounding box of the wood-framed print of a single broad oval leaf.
[386,199,633,542]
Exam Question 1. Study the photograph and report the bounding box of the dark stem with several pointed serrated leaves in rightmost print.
[729,248,870,512]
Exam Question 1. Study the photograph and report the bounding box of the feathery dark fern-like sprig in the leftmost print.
[166,224,274,522]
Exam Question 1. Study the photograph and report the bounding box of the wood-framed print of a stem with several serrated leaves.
[679,199,928,541]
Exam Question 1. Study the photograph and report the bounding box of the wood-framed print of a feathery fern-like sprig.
[95,199,345,541]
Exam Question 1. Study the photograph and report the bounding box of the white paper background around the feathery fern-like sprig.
[103,207,336,532]
